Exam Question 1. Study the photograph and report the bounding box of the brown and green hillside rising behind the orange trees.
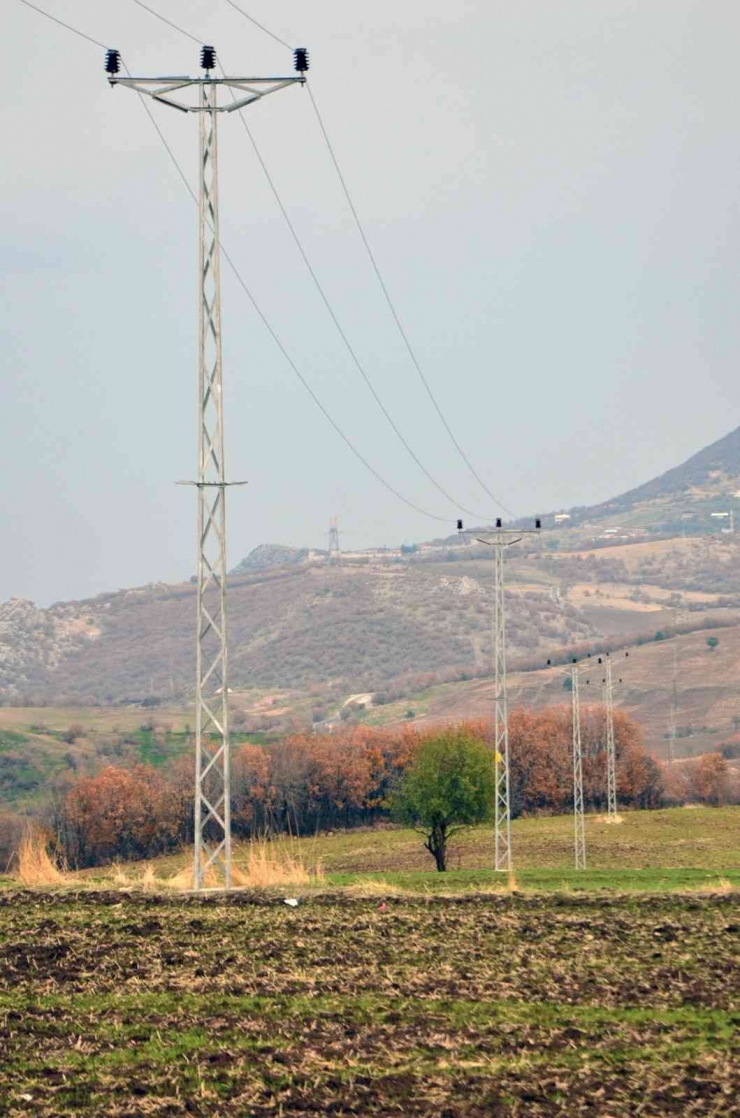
[0,420,740,800]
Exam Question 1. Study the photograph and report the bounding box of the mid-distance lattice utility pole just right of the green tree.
[457,518,542,871]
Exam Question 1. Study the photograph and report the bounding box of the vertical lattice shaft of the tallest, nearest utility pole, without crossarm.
[193,84,231,889]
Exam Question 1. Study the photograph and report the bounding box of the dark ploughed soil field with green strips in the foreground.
[0,891,740,1118]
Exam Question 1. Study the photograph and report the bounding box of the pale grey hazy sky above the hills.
[0,0,740,604]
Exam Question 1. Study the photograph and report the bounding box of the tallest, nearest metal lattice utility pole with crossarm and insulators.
[105,47,309,890]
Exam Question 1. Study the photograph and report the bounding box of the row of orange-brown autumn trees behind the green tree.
[40,708,663,866]
